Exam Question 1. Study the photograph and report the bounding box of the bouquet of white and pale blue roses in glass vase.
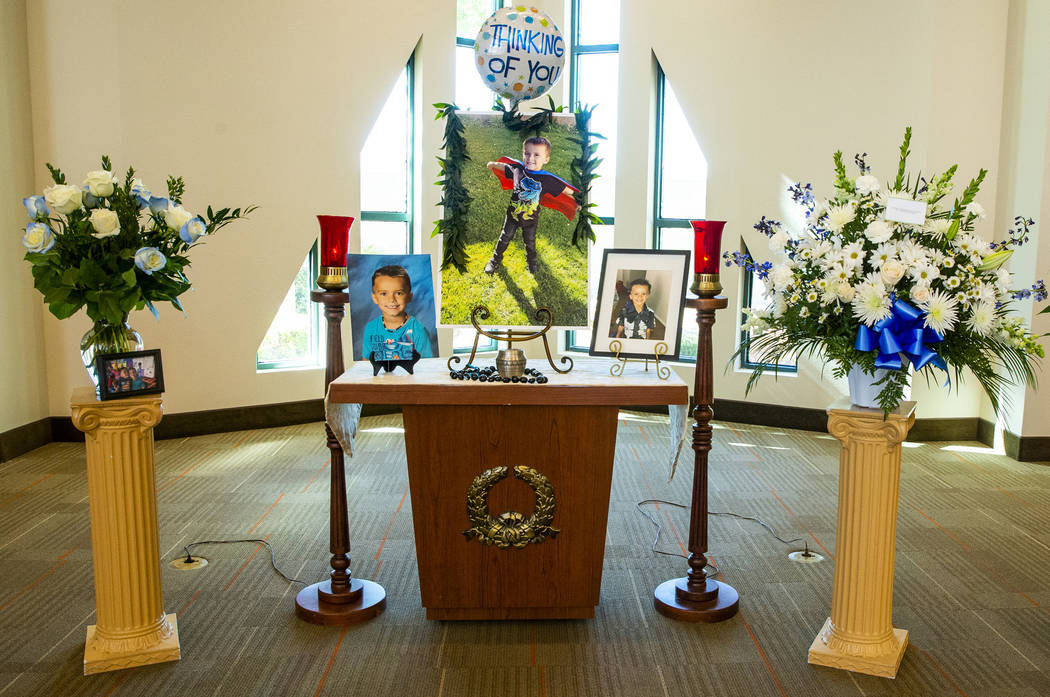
[22,155,255,377]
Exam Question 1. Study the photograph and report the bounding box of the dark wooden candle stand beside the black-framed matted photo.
[653,297,739,622]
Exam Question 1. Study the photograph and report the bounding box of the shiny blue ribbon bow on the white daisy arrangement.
[854,297,948,373]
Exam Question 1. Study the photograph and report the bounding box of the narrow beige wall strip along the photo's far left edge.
[0,0,48,432]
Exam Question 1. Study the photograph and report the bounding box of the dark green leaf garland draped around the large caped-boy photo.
[431,97,605,273]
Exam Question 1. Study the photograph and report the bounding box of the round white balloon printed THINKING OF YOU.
[474,5,565,104]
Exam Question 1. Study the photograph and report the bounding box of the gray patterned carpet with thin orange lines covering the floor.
[0,413,1050,697]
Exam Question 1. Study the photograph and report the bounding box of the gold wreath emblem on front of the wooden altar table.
[463,465,561,549]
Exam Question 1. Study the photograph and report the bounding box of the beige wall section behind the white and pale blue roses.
[28,0,455,415]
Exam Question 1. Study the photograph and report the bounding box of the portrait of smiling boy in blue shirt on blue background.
[347,254,438,373]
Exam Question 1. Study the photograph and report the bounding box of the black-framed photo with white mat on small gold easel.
[589,249,689,360]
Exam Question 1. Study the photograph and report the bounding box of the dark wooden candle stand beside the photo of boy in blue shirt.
[295,291,386,626]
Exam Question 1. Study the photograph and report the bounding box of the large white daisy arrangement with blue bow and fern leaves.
[723,128,1046,413]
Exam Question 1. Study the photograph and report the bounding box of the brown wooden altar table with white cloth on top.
[329,358,689,619]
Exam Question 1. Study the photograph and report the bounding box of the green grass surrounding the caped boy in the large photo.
[441,113,587,328]
